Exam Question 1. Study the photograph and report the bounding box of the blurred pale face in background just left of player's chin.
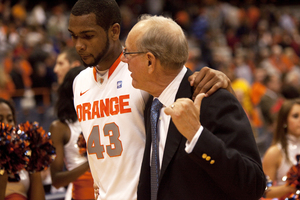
[53,53,72,84]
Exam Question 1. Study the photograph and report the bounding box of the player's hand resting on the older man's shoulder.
[189,67,235,99]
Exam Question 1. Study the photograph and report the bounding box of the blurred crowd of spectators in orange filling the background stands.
[0,0,300,159]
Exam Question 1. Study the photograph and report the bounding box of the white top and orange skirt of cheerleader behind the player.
[64,121,94,199]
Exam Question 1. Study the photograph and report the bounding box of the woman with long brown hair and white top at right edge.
[263,99,300,199]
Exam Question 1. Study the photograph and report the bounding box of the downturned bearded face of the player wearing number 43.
[68,13,110,66]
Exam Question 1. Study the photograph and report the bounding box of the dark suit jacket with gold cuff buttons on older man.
[137,70,266,200]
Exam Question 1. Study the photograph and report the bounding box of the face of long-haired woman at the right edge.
[287,104,300,137]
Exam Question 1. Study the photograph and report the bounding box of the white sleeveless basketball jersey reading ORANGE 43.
[73,57,145,200]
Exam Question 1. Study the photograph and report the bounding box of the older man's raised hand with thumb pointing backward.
[164,93,205,141]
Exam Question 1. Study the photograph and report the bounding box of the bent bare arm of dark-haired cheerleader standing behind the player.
[50,120,89,188]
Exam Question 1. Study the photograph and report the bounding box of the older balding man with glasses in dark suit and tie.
[121,16,266,200]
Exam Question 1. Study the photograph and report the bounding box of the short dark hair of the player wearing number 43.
[71,0,121,31]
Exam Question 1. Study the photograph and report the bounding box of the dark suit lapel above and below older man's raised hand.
[160,69,192,180]
